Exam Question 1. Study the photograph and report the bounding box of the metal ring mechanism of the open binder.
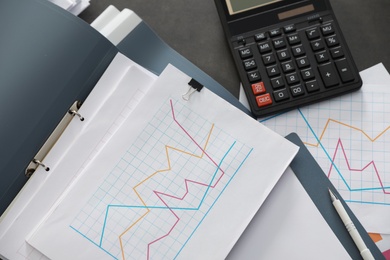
[25,101,84,178]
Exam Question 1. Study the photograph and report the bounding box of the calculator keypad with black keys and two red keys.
[237,21,361,116]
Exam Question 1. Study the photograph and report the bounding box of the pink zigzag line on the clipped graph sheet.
[147,100,225,259]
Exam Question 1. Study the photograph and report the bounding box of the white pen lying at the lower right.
[328,188,374,260]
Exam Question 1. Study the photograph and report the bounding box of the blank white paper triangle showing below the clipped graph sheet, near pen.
[227,167,350,260]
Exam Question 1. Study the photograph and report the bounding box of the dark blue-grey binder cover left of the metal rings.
[0,0,117,215]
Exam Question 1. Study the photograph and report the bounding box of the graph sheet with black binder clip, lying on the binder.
[28,66,297,259]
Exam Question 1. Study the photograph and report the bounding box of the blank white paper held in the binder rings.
[0,54,156,260]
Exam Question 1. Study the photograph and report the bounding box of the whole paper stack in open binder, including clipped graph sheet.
[0,49,298,259]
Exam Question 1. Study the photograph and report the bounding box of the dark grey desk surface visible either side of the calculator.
[80,0,390,97]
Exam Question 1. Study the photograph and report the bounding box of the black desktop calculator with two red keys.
[214,0,362,117]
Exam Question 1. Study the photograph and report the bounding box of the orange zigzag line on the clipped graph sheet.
[119,124,214,259]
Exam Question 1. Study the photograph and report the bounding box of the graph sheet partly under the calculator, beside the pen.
[260,63,390,234]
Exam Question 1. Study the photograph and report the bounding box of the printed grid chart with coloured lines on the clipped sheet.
[70,99,252,259]
